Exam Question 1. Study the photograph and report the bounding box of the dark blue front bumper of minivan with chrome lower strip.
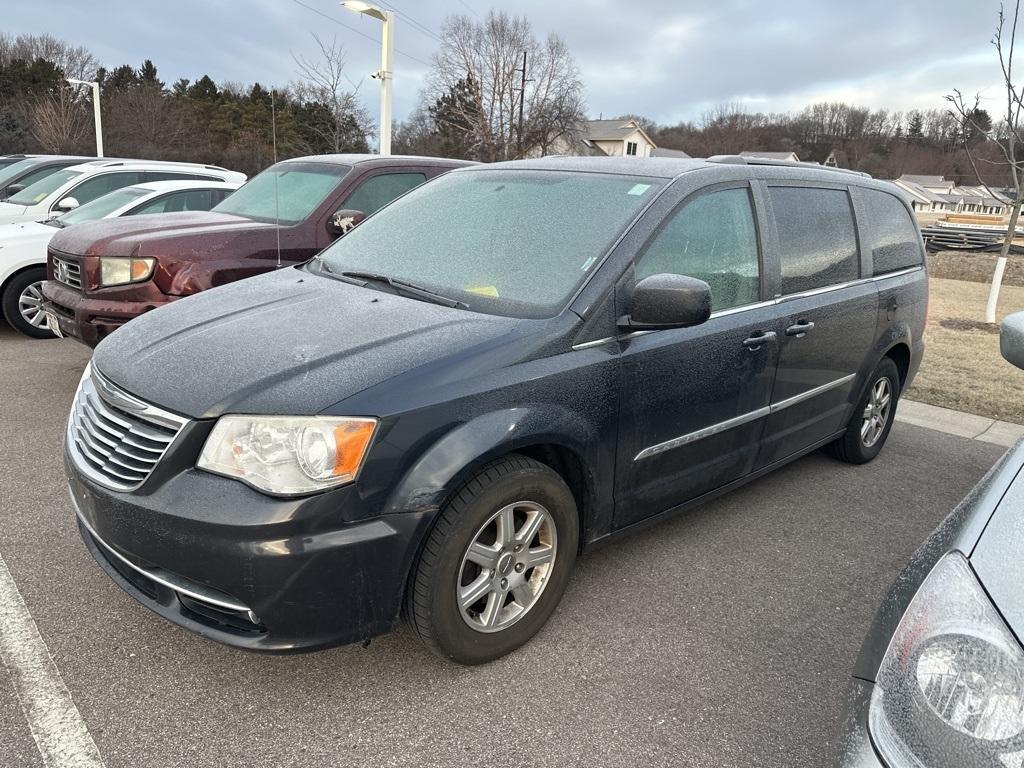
[65,449,431,652]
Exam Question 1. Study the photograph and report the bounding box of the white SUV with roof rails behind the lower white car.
[0,160,246,224]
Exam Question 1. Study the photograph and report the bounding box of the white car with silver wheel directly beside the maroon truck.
[0,180,242,339]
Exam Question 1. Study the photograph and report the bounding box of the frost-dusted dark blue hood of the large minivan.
[93,267,519,418]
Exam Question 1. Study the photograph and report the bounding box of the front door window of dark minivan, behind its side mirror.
[635,187,761,311]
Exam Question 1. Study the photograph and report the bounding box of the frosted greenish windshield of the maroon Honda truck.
[213,162,351,226]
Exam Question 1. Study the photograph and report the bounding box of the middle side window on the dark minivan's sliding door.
[770,186,860,296]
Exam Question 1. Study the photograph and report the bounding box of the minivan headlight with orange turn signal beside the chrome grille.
[197,416,377,496]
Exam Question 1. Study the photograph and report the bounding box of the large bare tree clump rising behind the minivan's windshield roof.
[425,11,585,161]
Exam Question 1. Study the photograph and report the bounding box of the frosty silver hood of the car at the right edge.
[971,440,1024,639]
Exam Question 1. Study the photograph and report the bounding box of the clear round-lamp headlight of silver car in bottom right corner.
[868,552,1024,768]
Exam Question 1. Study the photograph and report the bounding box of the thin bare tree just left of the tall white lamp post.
[291,35,374,153]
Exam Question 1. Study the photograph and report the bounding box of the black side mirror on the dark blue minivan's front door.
[618,273,711,331]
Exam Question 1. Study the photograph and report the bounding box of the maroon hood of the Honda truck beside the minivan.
[51,211,273,256]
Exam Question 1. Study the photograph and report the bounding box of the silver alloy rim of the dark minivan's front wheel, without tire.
[456,502,558,632]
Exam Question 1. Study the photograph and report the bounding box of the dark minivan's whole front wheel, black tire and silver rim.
[406,455,580,665]
